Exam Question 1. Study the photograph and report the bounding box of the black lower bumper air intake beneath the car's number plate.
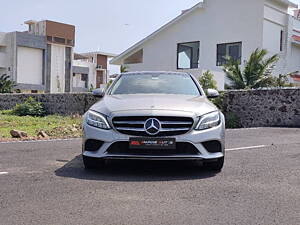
[106,141,200,156]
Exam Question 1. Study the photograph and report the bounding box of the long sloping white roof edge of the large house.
[110,0,206,65]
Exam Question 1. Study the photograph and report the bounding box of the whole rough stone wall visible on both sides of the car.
[0,89,300,127]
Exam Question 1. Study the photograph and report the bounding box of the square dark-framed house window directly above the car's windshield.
[177,41,200,69]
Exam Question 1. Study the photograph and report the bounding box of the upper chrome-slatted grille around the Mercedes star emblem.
[112,116,194,137]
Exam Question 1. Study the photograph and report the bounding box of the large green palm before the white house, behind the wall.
[223,49,279,89]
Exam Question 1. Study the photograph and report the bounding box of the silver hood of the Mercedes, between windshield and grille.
[91,95,218,116]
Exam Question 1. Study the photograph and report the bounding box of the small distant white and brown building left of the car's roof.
[73,51,120,92]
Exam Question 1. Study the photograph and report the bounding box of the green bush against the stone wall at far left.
[12,97,46,117]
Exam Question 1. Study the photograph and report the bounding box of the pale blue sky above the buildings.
[0,0,300,54]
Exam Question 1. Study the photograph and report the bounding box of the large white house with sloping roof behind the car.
[111,0,300,89]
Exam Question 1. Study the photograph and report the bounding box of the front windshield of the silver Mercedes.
[110,74,201,96]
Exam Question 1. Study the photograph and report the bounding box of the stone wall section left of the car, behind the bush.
[0,93,99,115]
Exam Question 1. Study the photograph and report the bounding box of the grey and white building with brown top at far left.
[0,20,75,93]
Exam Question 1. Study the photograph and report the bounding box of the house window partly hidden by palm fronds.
[217,42,242,66]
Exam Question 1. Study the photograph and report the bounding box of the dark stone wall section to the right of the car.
[224,89,300,127]
